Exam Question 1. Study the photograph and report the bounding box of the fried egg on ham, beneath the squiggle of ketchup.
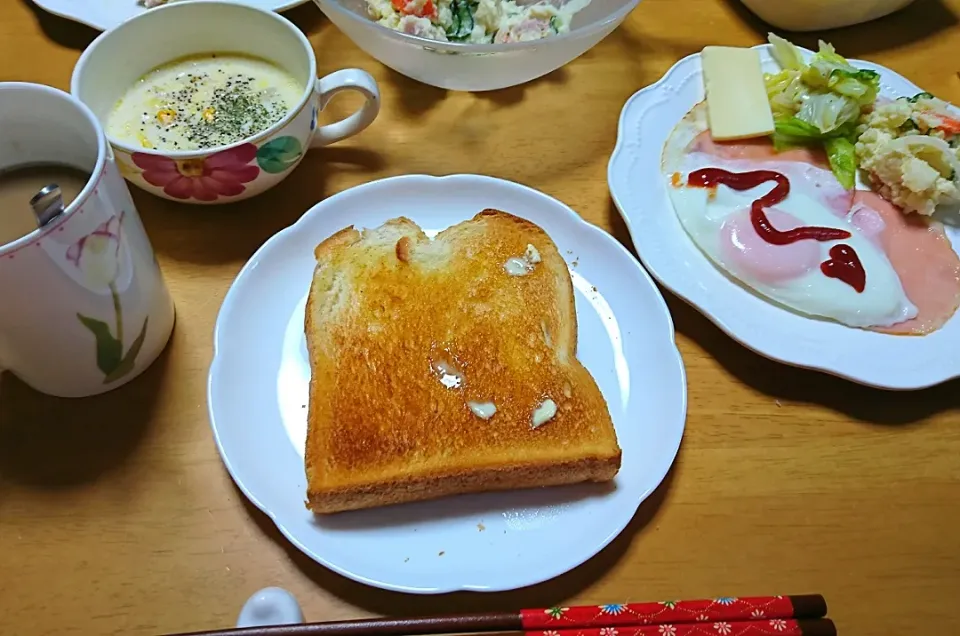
[663,102,917,328]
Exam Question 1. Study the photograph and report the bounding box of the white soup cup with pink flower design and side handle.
[71,0,380,203]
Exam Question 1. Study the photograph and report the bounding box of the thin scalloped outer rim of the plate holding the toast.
[207,175,687,594]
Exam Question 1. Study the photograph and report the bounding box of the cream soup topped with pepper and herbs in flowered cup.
[107,53,304,151]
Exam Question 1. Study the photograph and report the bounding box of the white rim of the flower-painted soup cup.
[70,0,318,161]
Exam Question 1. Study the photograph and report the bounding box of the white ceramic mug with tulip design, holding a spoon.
[0,82,174,397]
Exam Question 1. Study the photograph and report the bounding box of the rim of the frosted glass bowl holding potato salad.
[313,0,640,55]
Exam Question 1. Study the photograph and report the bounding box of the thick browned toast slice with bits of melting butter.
[305,210,620,513]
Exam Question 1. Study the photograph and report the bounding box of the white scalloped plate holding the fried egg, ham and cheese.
[607,45,960,390]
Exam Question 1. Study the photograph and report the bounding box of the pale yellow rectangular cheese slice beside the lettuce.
[700,46,773,141]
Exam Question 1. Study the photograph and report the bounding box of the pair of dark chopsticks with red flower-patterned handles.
[165,594,824,636]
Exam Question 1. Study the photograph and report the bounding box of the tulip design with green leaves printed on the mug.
[67,212,148,384]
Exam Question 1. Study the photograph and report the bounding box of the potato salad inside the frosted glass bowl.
[367,0,590,43]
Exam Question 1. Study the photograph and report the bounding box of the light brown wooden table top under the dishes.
[0,0,960,636]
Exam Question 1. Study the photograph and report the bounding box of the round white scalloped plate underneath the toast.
[208,175,686,594]
